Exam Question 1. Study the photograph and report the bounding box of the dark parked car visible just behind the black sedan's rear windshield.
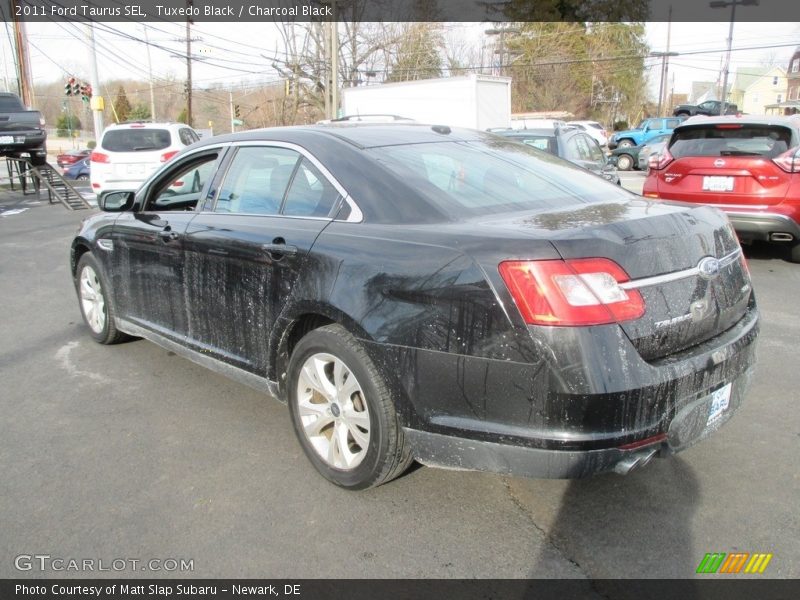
[494,126,621,185]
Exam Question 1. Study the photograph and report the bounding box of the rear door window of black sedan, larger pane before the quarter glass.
[214,146,300,215]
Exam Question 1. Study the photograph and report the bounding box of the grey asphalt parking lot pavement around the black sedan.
[0,180,800,578]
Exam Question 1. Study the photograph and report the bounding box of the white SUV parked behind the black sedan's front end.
[90,122,200,194]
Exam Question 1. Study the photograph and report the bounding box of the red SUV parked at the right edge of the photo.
[642,116,800,262]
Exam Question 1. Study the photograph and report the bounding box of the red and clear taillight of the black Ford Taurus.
[499,258,644,327]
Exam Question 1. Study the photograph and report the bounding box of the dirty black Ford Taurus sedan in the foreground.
[70,124,758,489]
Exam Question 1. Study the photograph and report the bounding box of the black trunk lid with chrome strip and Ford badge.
[483,200,751,360]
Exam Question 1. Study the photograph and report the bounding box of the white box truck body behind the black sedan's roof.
[342,75,511,130]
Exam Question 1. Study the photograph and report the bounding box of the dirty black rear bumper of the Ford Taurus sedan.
[372,306,759,478]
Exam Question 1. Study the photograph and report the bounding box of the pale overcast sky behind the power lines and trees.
[6,22,800,101]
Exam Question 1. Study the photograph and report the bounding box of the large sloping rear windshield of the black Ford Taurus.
[370,138,630,218]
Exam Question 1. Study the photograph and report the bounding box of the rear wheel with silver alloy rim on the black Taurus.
[287,325,413,490]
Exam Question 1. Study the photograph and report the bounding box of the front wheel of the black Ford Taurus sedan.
[75,252,130,344]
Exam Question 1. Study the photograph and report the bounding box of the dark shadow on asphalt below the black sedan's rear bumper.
[520,457,702,584]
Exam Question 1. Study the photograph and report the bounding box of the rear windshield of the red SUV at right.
[669,125,792,158]
